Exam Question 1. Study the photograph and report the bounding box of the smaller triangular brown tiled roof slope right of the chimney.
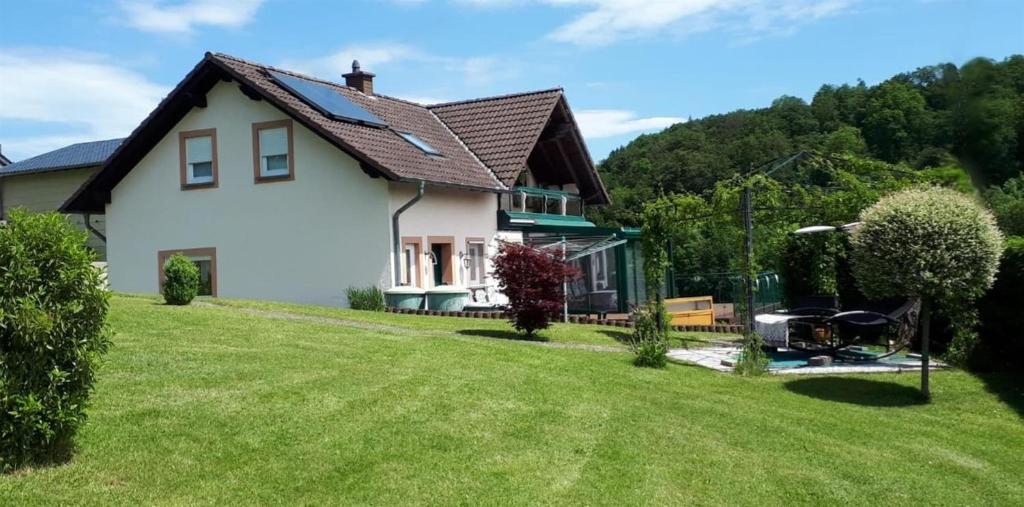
[429,88,562,186]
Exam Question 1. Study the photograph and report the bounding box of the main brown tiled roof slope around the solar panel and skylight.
[211,53,505,189]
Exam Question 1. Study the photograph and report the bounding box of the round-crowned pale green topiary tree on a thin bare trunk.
[851,187,1002,397]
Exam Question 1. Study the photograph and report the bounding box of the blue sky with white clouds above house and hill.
[0,0,1024,160]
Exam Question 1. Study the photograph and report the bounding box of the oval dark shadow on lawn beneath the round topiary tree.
[783,377,926,407]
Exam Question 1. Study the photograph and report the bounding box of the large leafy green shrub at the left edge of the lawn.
[0,210,109,471]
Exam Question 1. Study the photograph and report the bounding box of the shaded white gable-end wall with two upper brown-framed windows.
[106,83,391,305]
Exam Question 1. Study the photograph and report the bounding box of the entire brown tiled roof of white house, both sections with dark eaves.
[62,53,607,212]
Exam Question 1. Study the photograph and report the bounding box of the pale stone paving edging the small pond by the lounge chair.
[669,346,947,375]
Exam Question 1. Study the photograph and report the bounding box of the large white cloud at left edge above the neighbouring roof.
[0,49,170,160]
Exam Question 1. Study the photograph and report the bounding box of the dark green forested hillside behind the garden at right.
[593,55,1024,225]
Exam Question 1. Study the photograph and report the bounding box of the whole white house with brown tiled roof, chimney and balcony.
[62,53,622,304]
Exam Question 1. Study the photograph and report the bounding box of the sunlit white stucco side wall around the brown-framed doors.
[389,182,498,288]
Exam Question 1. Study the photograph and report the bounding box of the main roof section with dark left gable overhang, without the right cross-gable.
[63,53,506,212]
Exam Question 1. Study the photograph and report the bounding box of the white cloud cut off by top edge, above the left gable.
[121,0,263,34]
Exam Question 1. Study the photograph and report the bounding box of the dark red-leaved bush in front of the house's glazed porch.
[495,243,580,336]
